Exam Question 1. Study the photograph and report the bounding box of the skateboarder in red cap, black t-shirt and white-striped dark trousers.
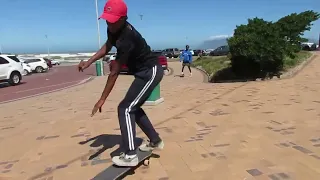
[78,0,164,166]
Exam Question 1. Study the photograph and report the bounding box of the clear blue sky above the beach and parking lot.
[0,0,320,53]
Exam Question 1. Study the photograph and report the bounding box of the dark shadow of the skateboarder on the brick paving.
[79,134,143,160]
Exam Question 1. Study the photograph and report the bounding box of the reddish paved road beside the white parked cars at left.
[0,66,109,103]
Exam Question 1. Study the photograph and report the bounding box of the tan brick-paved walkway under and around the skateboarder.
[0,54,320,180]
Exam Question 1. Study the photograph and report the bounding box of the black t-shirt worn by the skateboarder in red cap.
[108,22,159,73]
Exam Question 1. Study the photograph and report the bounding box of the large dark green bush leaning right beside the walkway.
[228,11,320,77]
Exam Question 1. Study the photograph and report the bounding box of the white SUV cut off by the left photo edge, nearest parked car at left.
[0,54,23,86]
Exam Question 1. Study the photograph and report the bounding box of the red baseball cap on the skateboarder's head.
[99,0,128,23]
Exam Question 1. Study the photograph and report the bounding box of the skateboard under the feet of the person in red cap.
[92,150,152,180]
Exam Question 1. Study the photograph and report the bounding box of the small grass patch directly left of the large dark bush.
[192,56,230,76]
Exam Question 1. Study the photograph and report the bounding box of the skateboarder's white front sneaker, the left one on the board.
[112,153,139,167]
